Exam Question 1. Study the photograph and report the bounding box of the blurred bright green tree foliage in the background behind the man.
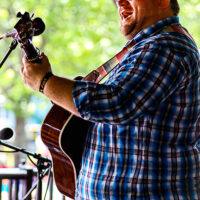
[0,0,200,164]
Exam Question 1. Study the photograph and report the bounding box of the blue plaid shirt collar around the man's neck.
[128,16,179,43]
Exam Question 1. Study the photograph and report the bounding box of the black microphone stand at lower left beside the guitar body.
[0,140,52,200]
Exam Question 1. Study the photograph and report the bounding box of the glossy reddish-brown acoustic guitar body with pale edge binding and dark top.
[41,105,90,198]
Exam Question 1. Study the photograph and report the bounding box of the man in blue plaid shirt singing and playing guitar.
[21,0,200,200]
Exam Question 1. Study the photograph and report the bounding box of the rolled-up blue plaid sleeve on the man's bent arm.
[73,43,184,124]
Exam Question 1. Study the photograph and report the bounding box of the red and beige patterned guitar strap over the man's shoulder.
[83,24,195,83]
